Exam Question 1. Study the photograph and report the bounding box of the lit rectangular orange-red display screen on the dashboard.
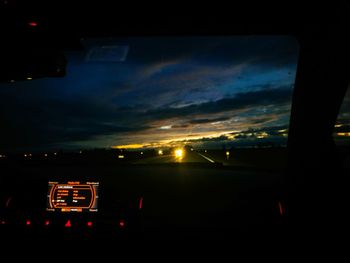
[46,181,99,212]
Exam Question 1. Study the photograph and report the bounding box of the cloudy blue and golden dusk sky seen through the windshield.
[0,36,298,151]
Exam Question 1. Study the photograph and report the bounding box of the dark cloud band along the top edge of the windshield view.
[117,36,298,65]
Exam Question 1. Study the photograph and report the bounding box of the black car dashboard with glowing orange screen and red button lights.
[0,165,285,241]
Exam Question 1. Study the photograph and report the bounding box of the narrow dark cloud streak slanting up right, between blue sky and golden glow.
[145,87,291,119]
